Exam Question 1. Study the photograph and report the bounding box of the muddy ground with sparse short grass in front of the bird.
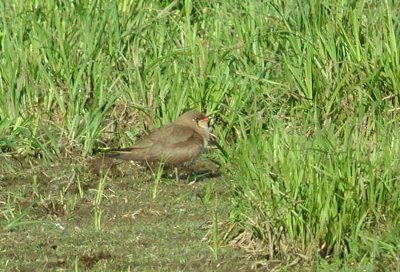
[0,159,256,271]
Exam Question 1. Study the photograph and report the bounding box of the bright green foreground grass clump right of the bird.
[228,111,399,258]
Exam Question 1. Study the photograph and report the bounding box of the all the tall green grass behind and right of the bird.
[0,0,400,268]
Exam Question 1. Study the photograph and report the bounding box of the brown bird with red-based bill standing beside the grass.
[104,110,211,181]
